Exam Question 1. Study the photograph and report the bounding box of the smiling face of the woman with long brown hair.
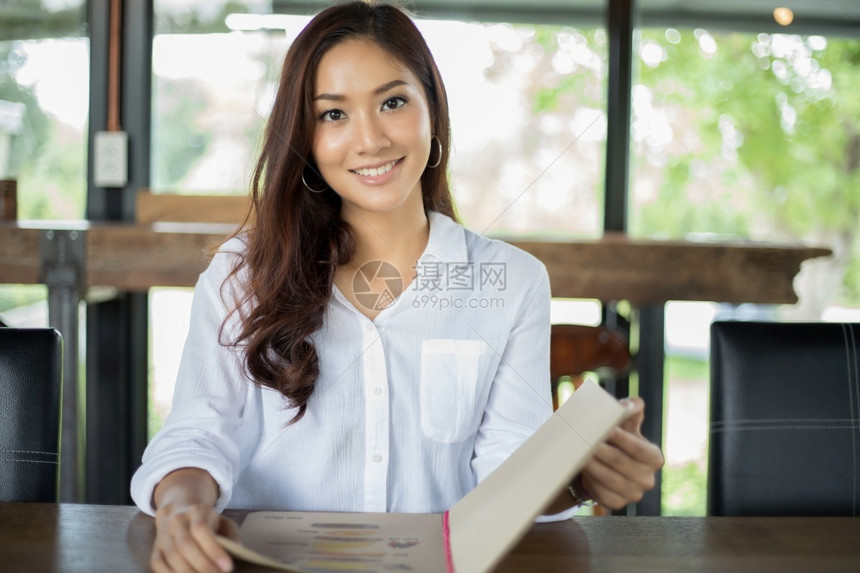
[312,39,432,219]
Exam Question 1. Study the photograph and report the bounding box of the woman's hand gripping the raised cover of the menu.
[580,397,663,509]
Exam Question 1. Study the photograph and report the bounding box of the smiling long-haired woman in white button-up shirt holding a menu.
[132,2,662,571]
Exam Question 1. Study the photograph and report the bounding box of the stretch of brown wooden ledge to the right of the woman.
[511,236,832,304]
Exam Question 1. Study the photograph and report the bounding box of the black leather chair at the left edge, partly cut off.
[0,328,63,502]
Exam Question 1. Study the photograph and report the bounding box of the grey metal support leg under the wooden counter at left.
[41,230,86,503]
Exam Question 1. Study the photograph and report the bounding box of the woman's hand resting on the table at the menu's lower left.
[150,503,239,573]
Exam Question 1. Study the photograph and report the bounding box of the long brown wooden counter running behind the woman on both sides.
[0,221,831,304]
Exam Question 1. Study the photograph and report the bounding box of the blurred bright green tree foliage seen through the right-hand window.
[634,30,860,303]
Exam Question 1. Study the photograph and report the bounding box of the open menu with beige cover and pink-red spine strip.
[219,382,627,573]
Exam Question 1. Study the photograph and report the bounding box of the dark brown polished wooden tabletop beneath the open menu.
[0,503,860,573]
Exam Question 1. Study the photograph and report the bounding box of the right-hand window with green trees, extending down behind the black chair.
[630,22,860,514]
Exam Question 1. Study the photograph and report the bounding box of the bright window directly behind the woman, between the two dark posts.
[150,0,608,431]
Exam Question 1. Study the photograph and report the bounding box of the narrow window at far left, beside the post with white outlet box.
[0,0,89,327]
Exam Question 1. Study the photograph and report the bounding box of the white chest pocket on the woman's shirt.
[419,338,491,443]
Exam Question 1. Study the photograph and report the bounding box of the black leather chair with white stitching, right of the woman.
[708,322,860,516]
